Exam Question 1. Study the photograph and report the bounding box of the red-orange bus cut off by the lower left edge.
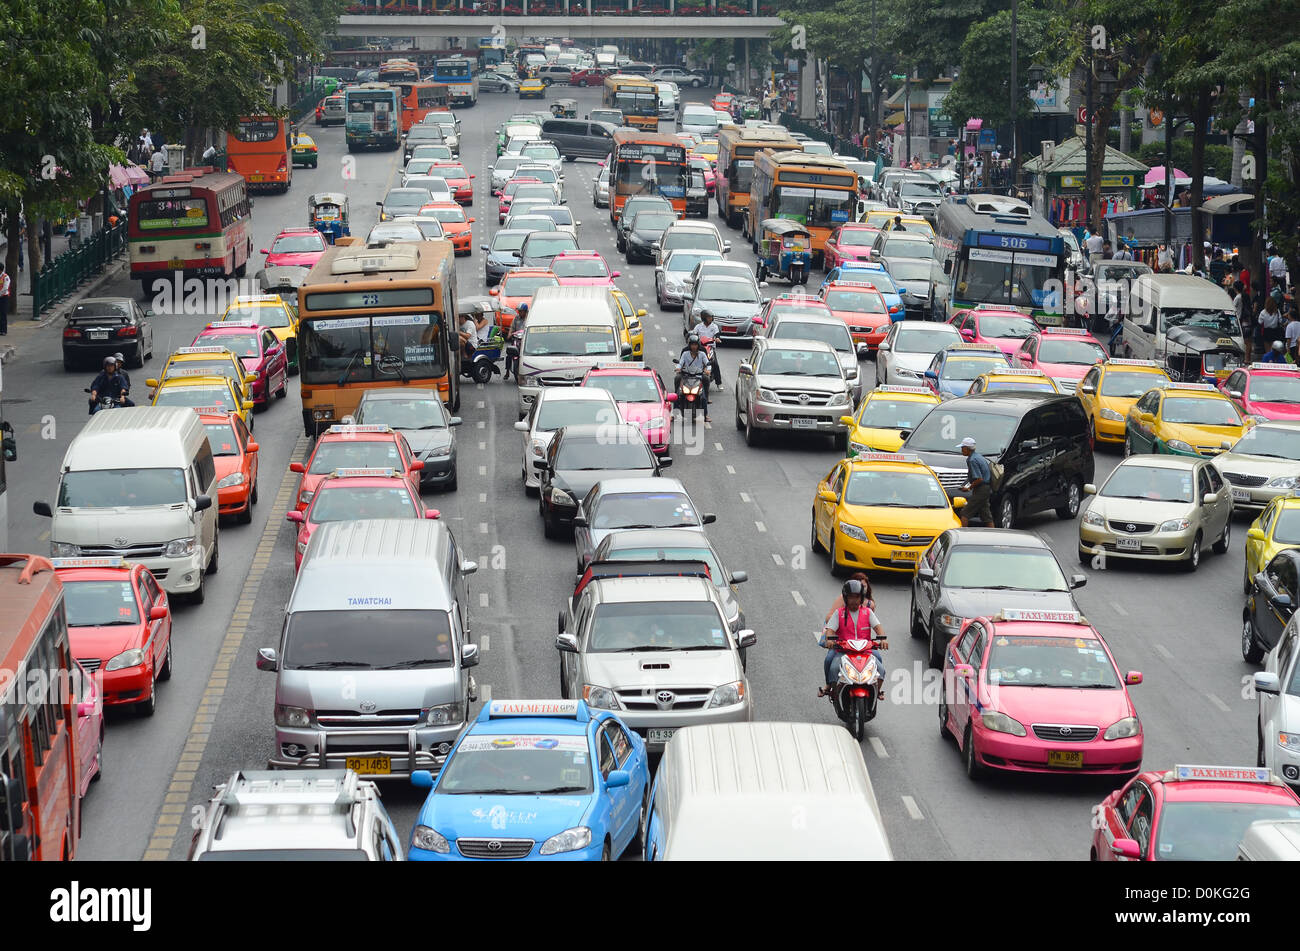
[0,555,81,861]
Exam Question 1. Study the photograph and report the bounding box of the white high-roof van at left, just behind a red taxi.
[33,407,217,604]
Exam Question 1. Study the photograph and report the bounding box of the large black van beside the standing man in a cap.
[902,391,1093,529]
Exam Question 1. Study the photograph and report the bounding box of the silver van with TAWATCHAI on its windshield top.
[257,518,478,778]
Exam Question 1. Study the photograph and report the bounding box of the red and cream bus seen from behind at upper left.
[126,166,252,298]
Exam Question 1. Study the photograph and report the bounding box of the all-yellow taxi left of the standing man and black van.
[813,452,966,574]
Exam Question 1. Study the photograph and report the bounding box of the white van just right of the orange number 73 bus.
[519,286,632,420]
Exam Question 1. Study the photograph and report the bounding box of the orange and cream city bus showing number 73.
[298,242,460,435]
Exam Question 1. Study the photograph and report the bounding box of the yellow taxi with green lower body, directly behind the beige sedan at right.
[1125,383,1255,456]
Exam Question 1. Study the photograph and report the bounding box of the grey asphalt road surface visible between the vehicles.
[5,90,1256,860]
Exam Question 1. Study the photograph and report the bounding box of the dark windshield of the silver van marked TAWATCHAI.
[281,608,451,670]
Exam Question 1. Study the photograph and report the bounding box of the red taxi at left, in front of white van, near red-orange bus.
[52,556,172,716]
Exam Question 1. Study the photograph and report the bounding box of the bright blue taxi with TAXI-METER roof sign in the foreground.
[407,700,650,861]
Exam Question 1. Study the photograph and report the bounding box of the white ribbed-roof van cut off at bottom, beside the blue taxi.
[645,722,893,861]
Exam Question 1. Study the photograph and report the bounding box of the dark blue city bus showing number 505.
[931,195,1066,326]
